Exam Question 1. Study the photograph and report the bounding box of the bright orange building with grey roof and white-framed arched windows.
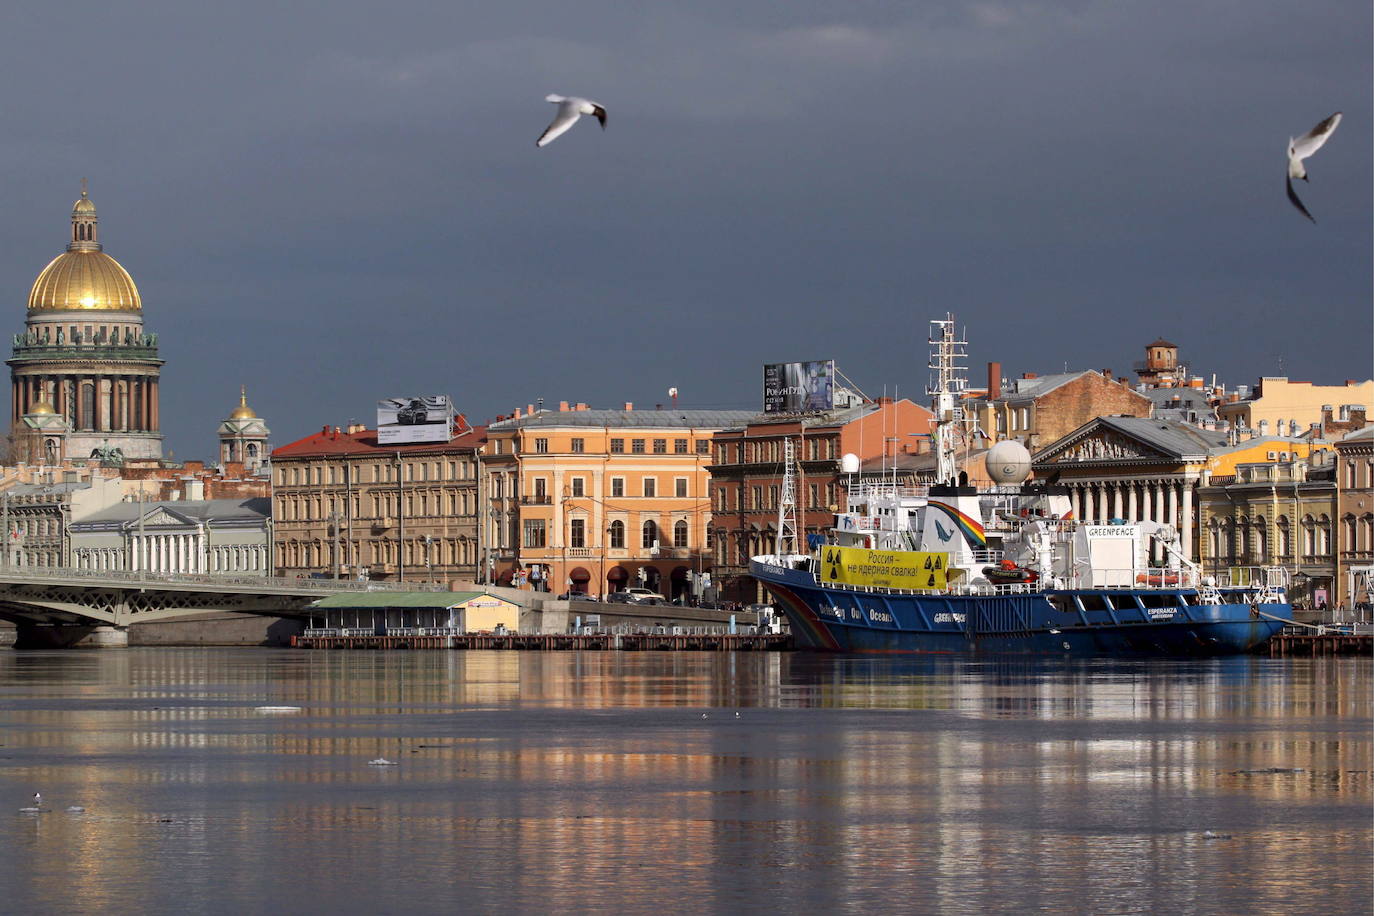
[482,401,754,599]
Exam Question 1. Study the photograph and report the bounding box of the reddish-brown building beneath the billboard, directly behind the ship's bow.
[708,398,934,603]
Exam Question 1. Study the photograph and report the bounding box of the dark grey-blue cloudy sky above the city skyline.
[0,0,1374,457]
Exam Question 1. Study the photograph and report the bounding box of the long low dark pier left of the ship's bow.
[291,633,791,652]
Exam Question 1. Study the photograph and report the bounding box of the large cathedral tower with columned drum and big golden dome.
[7,181,162,459]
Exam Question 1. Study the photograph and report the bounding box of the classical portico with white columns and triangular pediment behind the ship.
[1035,416,1221,558]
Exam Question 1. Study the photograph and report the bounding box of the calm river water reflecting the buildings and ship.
[0,648,1374,913]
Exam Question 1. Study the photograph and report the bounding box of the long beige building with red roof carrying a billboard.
[272,426,484,582]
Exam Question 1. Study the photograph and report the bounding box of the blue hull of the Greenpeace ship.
[750,562,1293,655]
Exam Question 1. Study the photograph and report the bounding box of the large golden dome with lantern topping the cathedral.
[29,181,143,313]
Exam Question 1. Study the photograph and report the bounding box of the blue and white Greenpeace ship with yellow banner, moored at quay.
[749,314,1293,656]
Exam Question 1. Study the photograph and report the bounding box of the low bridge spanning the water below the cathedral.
[0,566,453,648]
